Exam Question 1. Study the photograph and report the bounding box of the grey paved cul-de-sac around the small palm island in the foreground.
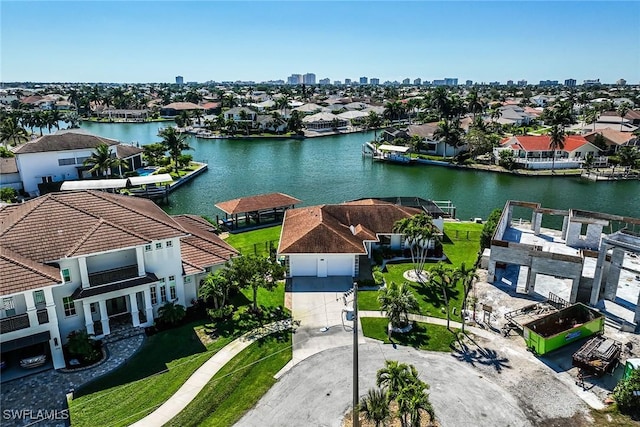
[236,343,532,427]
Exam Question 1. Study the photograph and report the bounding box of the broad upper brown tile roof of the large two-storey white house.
[0,191,186,263]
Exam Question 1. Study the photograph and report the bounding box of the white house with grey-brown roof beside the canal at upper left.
[12,129,143,195]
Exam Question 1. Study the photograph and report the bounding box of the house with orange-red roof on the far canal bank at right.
[494,135,607,169]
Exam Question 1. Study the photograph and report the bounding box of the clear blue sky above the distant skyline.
[0,0,640,83]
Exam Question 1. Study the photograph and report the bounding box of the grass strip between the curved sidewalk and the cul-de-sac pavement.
[166,332,291,427]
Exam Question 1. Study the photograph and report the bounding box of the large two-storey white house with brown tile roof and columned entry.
[0,191,238,369]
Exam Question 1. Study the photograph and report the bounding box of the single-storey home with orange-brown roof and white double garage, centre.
[278,199,442,278]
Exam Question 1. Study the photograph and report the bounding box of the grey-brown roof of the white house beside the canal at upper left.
[13,130,119,154]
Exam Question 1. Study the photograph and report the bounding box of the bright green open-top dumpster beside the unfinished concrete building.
[522,303,604,355]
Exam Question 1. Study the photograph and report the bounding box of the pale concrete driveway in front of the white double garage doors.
[287,277,364,368]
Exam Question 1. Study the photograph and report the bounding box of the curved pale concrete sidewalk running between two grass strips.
[132,319,291,427]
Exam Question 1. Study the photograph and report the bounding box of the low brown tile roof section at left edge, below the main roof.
[0,246,62,295]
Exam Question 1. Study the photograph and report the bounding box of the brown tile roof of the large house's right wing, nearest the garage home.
[173,215,239,274]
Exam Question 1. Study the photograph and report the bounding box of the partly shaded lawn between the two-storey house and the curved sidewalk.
[69,283,284,426]
